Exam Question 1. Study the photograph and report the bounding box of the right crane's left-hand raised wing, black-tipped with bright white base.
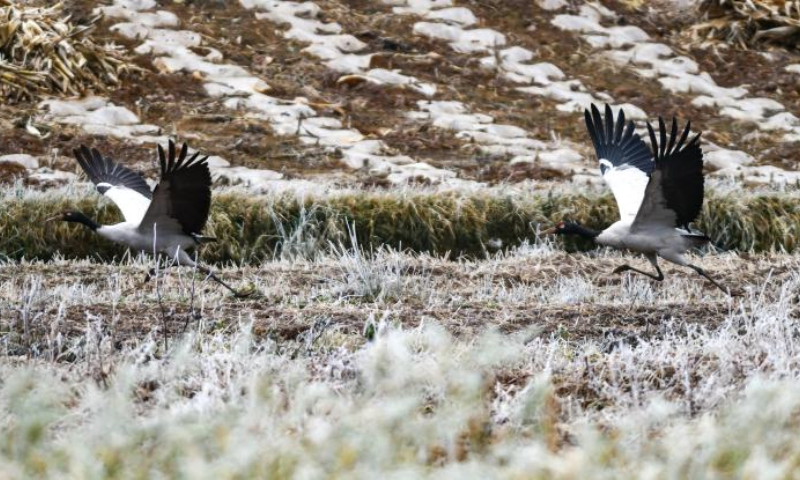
[584,104,655,222]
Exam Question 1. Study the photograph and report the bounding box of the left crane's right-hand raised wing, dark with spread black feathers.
[141,140,211,235]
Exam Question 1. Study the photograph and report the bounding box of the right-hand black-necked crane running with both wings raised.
[545,105,730,293]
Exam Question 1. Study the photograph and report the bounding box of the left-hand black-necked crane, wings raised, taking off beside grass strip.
[48,140,247,297]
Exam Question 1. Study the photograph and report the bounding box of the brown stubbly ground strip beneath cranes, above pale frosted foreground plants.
[0,248,797,352]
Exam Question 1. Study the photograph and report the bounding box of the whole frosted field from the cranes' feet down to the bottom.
[0,244,800,479]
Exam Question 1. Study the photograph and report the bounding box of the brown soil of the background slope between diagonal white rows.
[0,0,800,187]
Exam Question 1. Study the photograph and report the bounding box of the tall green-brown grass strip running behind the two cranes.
[0,183,800,264]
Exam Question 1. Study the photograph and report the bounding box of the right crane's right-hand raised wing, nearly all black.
[631,117,704,230]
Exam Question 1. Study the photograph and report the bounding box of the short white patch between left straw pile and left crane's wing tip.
[39,96,167,143]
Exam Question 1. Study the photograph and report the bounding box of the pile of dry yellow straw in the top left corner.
[0,0,132,100]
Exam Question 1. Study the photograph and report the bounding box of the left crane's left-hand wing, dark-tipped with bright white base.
[73,145,152,223]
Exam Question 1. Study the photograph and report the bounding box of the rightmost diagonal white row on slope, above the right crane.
[552,4,800,142]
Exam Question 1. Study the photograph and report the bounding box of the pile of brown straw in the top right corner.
[693,0,800,49]
